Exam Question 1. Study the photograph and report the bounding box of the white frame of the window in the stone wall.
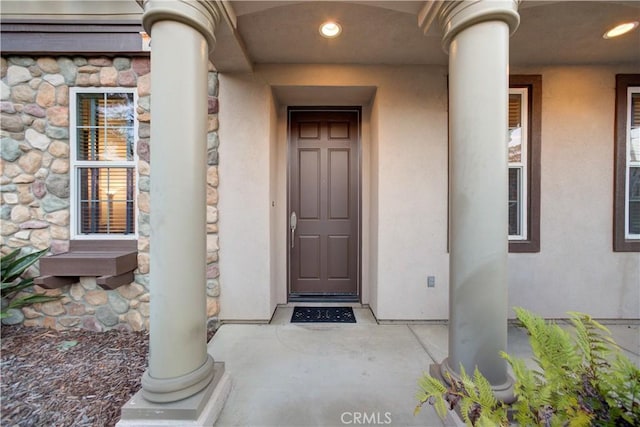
[69,87,139,240]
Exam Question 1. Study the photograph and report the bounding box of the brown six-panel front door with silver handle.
[288,108,360,299]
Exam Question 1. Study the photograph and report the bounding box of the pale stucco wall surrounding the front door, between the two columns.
[215,66,448,320]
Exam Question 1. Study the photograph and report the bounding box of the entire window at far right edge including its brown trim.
[613,74,640,252]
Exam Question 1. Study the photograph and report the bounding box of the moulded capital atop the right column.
[418,0,520,52]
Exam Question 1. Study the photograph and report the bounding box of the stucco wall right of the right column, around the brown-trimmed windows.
[509,67,640,318]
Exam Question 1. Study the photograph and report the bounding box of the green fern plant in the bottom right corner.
[415,308,640,427]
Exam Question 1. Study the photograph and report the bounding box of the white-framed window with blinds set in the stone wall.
[71,88,137,238]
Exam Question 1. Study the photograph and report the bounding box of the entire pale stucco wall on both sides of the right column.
[219,65,640,320]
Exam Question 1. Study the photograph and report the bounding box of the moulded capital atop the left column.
[136,0,222,56]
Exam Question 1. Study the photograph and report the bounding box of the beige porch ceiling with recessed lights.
[214,0,640,71]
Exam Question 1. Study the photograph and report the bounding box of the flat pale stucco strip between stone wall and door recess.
[218,75,274,320]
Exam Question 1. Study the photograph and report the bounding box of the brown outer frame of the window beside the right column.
[505,74,542,253]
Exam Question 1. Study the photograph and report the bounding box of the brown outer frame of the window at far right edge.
[613,74,640,252]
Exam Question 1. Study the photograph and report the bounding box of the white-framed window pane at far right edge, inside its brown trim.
[625,87,640,239]
